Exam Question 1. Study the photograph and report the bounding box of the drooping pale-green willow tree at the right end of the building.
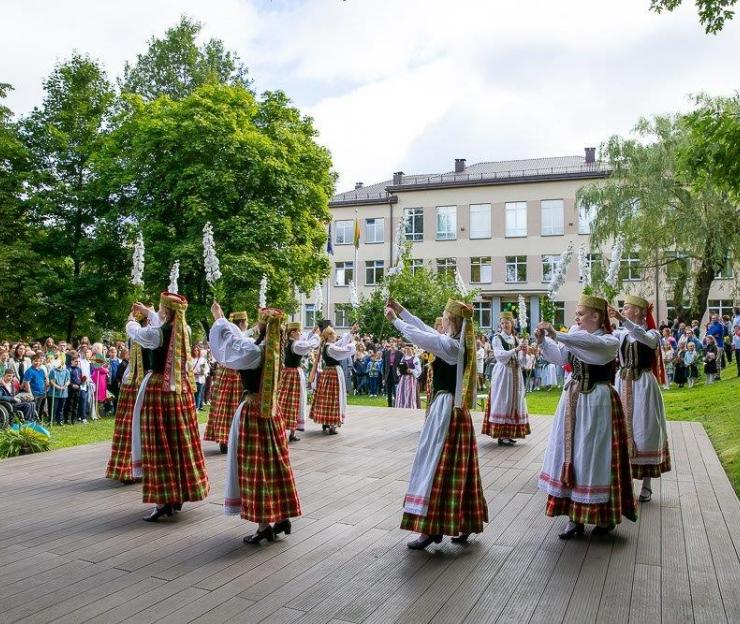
[577,116,740,319]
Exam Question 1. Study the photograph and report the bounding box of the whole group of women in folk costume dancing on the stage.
[106,292,670,550]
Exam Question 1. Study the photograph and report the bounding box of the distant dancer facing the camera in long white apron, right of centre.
[482,312,532,446]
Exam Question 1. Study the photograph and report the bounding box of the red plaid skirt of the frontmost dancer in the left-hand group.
[237,401,301,522]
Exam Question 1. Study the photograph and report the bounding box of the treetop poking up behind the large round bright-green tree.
[119,17,251,100]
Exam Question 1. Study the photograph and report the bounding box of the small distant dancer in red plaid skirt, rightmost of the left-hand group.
[311,323,359,435]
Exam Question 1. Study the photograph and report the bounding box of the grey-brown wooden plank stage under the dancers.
[0,407,740,624]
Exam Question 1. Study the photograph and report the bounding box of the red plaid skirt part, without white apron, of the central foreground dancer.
[401,409,488,535]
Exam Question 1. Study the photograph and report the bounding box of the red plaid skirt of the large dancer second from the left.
[141,373,210,504]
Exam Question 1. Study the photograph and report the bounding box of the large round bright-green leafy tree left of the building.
[104,84,334,318]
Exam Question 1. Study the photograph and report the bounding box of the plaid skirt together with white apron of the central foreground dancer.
[401,394,488,536]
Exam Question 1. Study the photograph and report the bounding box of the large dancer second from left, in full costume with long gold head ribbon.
[126,292,210,522]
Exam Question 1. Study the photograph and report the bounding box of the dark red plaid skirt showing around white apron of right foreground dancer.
[545,388,637,526]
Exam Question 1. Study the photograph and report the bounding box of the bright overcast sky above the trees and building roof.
[0,0,740,191]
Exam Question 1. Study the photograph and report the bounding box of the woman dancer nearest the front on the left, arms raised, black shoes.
[210,302,301,545]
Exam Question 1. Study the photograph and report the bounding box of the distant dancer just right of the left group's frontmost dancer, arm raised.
[278,323,321,442]
